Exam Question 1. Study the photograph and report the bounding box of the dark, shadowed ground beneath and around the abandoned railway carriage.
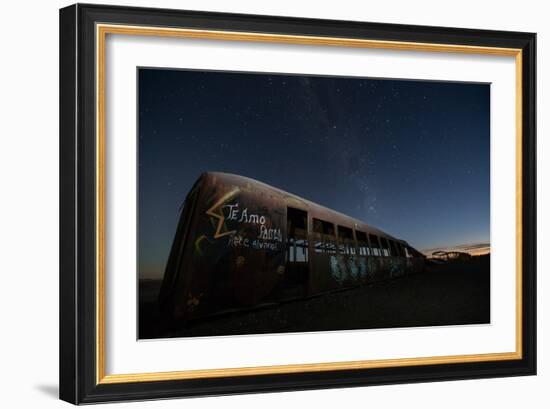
[139,255,490,339]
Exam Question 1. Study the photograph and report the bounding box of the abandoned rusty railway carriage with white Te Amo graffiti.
[159,172,425,320]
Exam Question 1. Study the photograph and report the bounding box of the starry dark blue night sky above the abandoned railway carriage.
[138,69,490,278]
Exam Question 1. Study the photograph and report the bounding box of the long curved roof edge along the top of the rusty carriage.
[199,172,418,246]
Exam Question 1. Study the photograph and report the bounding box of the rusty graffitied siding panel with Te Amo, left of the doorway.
[170,174,286,318]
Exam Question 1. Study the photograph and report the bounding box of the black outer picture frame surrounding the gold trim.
[59,4,536,404]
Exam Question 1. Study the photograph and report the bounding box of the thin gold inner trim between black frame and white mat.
[95,24,523,384]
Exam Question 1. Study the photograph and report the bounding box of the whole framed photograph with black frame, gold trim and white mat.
[60,5,536,404]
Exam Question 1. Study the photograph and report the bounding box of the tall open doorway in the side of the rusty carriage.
[284,207,309,297]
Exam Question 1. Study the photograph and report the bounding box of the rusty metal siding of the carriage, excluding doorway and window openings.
[160,173,424,319]
